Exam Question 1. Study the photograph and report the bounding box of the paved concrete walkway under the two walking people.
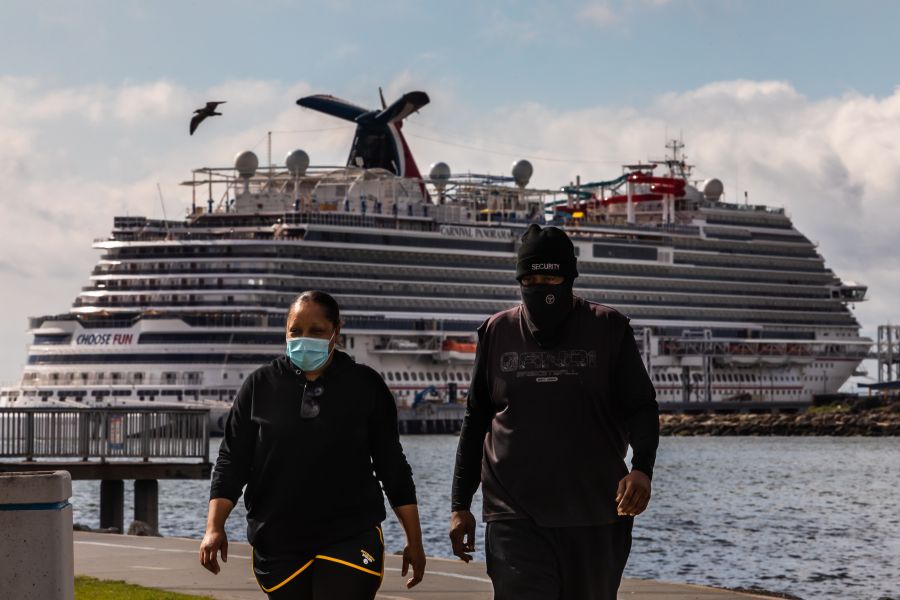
[75,532,771,600]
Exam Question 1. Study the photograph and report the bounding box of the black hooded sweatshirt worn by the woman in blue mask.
[210,350,416,555]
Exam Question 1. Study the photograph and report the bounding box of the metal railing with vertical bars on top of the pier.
[0,408,209,462]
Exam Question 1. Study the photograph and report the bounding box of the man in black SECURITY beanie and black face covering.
[450,225,659,600]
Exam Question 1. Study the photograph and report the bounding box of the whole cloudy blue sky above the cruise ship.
[0,0,900,382]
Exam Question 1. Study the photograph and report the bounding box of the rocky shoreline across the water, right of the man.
[659,402,900,437]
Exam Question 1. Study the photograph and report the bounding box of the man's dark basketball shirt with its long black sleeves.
[452,298,659,527]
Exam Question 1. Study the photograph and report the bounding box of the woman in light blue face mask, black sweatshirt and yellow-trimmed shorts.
[200,291,425,600]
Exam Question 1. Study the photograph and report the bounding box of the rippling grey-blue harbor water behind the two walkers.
[73,436,900,600]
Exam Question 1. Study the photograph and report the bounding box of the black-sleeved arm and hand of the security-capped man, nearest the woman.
[450,322,494,562]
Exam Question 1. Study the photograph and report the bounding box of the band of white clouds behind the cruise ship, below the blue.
[0,72,900,380]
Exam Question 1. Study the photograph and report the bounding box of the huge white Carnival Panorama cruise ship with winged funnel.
[0,92,872,426]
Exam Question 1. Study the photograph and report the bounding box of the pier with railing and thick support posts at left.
[0,407,212,531]
